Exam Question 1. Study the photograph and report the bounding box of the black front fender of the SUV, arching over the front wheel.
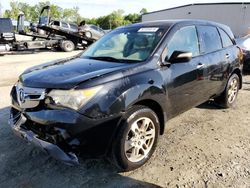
[81,70,166,118]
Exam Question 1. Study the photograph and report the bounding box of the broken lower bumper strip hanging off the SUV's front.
[9,113,79,165]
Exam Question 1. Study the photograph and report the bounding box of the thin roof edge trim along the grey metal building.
[143,2,250,15]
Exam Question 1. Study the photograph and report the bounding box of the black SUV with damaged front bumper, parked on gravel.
[10,20,242,171]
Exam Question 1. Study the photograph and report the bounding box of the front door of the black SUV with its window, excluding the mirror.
[162,26,208,118]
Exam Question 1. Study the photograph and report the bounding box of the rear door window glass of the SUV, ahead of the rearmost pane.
[197,26,222,53]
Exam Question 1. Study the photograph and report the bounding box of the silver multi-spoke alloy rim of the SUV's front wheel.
[124,117,156,162]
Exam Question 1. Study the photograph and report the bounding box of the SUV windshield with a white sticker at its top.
[81,27,165,63]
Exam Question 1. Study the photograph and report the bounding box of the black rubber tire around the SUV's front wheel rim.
[114,107,160,171]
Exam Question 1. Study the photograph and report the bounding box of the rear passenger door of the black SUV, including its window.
[197,25,227,97]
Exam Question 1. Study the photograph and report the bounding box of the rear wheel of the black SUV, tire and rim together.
[214,74,240,108]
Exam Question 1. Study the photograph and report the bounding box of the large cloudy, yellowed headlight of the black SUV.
[45,86,102,110]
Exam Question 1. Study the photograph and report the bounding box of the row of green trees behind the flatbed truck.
[4,1,147,29]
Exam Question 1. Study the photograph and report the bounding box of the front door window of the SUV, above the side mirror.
[167,26,199,57]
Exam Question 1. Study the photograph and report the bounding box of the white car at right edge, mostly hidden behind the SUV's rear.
[236,35,250,71]
